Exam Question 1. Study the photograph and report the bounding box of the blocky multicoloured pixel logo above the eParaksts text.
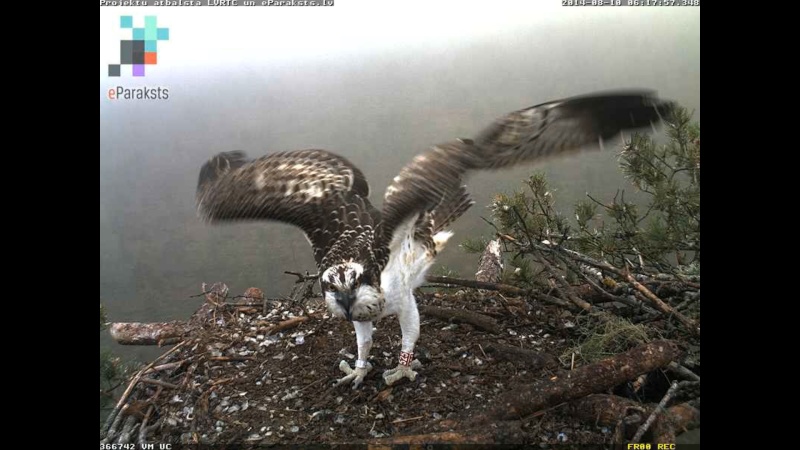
[108,16,169,77]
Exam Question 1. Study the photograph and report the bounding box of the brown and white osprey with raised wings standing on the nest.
[197,91,673,388]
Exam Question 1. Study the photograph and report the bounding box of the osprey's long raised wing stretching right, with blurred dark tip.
[375,91,673,264]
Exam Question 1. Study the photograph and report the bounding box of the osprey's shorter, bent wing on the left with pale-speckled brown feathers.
[197,150,380,264]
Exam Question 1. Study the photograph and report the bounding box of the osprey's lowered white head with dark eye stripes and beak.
[320,261,383,321]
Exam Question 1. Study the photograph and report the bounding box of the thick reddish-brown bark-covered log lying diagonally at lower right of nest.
[492,341,680,420]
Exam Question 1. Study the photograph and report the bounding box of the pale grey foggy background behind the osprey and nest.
[100,0,700,358]
